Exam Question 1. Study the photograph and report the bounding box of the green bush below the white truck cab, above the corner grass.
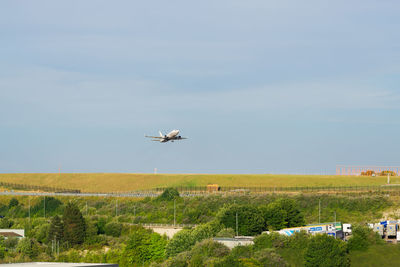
[347,225,384,251]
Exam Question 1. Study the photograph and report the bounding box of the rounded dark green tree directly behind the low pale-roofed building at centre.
[219,204,265,236]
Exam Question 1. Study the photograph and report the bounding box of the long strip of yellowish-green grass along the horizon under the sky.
[0,173,400,192]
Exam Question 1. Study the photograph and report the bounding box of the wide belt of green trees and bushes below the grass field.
[0,189,391,266]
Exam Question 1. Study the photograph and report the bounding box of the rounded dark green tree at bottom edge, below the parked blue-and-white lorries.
[304,234,350,267]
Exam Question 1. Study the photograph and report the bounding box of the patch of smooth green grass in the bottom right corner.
[350,245,400,267]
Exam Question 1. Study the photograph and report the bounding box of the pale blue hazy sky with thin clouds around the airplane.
[0,0,400,174]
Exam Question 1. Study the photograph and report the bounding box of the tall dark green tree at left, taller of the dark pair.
[63,202,86,245]
